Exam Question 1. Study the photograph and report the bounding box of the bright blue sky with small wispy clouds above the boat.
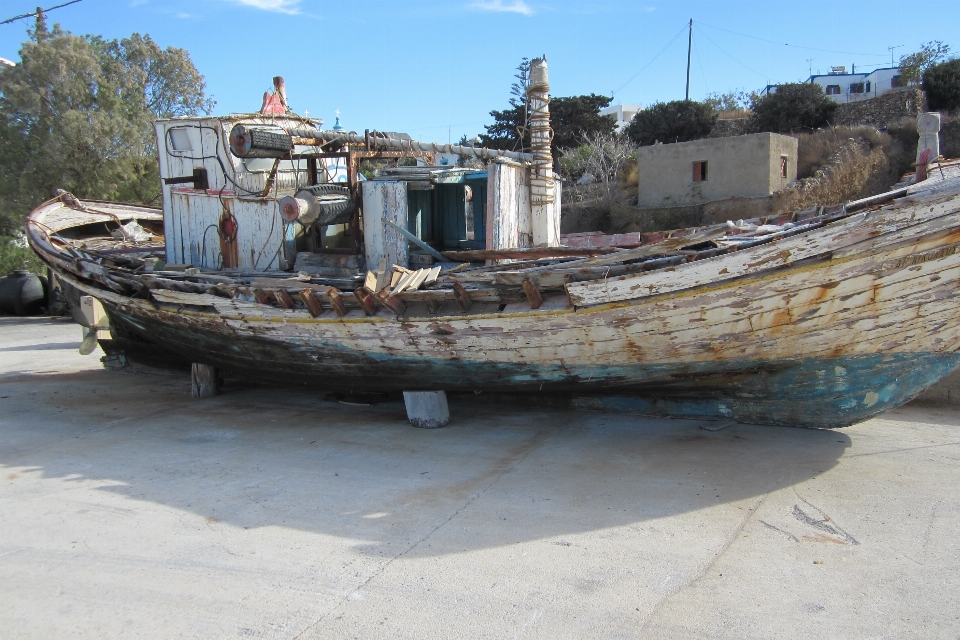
[0,0,960,142]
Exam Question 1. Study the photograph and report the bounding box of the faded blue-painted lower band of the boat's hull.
[110,309,960,427]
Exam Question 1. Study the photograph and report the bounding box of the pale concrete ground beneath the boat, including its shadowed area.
[0,318,960,640]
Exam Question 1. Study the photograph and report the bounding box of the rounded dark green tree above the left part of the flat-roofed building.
[624,100,717,146]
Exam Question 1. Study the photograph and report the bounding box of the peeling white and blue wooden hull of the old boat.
[28,167,960,427]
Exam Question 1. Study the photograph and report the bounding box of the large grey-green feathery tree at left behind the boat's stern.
[0,18,214,234]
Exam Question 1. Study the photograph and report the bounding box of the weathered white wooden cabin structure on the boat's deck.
[155,105,560,278]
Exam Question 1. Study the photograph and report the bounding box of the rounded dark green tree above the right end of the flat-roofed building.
[750,82,837,133]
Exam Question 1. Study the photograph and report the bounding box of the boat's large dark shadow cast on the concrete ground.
[0,369,850,556]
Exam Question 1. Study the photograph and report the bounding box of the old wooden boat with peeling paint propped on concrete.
[20,62,960,427]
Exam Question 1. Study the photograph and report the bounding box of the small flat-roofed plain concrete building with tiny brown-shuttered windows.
[637,133,797,207]
